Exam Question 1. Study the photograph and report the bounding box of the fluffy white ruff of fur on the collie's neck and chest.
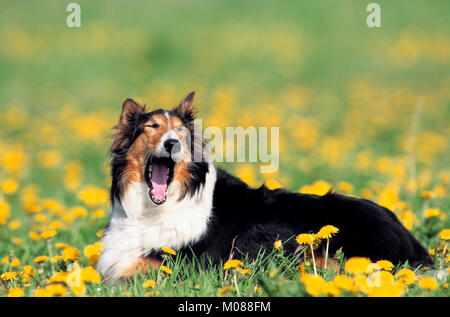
[97,164,216,279]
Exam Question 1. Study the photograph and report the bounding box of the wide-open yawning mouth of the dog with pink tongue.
[145,157,175,205]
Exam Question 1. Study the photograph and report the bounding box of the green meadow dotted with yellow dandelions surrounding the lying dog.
[0,0,450,297]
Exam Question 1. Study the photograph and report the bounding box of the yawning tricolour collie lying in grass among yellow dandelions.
[97,92,433,280]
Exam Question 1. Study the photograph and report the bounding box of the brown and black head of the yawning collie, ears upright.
[111,92,208,205]
